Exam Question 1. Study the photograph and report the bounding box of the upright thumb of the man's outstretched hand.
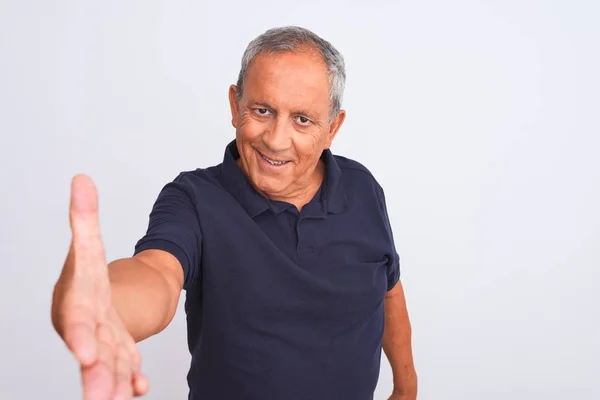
[69,174,104,265]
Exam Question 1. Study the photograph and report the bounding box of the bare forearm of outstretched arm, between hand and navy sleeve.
[108,258,181,342]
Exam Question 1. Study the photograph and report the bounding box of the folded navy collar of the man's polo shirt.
[220,139,347,218]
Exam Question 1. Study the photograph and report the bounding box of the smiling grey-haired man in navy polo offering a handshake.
[52,27,417,400]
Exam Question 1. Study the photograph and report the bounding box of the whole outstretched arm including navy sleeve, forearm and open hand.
[51,175,200,398]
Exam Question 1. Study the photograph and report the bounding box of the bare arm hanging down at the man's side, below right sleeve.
[383,281,417,400]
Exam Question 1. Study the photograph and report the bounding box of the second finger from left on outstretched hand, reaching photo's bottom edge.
[81,324,116,400]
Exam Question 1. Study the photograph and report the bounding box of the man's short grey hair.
[237,26,346,120]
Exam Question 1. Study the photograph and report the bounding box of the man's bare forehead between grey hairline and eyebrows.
[244,50,329,110]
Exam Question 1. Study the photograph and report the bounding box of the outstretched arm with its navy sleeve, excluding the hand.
[108,175,201,342]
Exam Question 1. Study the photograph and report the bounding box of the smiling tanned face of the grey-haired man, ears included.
[229,50,345,202]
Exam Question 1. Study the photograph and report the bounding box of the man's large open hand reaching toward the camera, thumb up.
[52,175,148,400]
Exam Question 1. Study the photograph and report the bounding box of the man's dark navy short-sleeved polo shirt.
[135,141,400,400]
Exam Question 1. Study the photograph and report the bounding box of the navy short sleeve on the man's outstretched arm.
[134,173,202,290]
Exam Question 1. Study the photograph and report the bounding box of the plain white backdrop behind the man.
[0,0,600,400]
